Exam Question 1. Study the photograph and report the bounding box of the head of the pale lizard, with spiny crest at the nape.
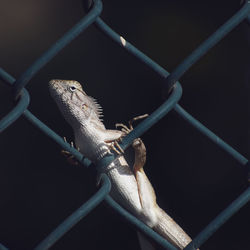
[49,80,102,127]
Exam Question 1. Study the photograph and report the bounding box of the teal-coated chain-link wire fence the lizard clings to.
[0,0,250,250]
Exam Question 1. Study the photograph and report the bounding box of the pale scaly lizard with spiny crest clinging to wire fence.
[49,79,191,249]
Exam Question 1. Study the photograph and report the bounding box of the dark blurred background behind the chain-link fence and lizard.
[0,0,250,250]
